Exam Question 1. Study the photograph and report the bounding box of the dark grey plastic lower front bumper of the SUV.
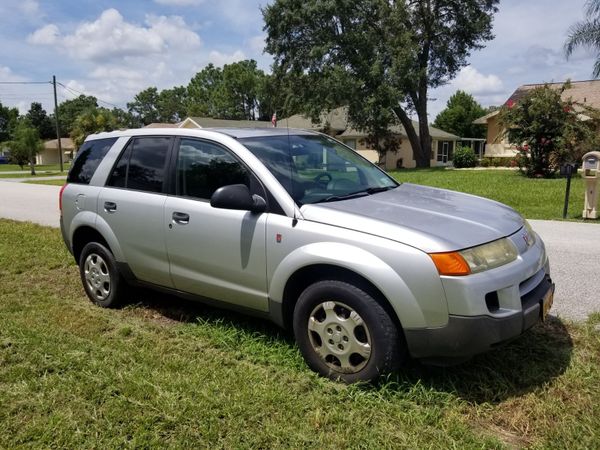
[404,275,554,364]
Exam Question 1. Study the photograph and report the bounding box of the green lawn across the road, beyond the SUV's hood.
[390,168,598,222]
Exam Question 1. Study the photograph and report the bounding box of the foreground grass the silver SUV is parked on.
[0,220,600,449]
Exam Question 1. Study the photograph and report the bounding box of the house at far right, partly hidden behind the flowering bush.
[473,80,600,158]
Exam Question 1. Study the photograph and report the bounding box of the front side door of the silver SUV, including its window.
[165,138,268,311]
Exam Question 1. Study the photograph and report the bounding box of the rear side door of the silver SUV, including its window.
[98,136,173,287]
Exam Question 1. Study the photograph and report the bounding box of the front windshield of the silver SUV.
[239,135,398,205]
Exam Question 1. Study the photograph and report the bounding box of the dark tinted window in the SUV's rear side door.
[107,137,171,192]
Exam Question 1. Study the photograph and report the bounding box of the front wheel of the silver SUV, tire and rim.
[293,280,407,383]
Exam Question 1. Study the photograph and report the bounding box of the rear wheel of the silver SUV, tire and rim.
[79,242,127,308]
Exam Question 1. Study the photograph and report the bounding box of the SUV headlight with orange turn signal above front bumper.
[429,238,518,276]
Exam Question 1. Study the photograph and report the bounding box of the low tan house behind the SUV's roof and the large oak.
[146,108,461,170]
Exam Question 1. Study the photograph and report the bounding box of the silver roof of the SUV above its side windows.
[86,126,320,140]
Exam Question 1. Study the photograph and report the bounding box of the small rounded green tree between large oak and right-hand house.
[433,90,487,138]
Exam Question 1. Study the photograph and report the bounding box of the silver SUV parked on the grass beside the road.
[61,128,554,382]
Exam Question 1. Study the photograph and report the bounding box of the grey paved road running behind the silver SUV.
[0,181,600,320]
